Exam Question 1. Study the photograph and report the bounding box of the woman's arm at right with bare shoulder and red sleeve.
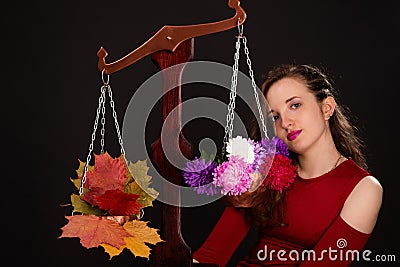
[299,176,383,267]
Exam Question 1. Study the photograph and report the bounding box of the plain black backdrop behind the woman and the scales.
[6,0,400,266]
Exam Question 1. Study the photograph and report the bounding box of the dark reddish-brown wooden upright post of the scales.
[151,39,194,267]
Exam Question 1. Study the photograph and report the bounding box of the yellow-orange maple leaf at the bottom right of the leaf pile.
[124,220,163,259]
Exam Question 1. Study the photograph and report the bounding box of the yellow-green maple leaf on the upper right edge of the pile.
[124,160,158,207]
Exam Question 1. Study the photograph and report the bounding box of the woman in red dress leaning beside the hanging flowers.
[193,65,382,267]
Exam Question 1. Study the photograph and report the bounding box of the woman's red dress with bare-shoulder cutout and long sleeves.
[193,159,371,267]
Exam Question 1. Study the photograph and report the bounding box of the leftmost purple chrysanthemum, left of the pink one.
[182,157,218,195]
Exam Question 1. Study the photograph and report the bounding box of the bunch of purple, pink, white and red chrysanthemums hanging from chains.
[183,136,296,195]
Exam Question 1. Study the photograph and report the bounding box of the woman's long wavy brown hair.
[225,64,367,228]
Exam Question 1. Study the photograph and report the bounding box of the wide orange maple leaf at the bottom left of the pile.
[59,215,129,248]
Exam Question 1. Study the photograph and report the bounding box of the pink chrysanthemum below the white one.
[214,155,252,195]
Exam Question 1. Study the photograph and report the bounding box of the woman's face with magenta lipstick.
[266,78,329,154]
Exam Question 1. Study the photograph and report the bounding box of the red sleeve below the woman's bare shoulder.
[299,216,371,267]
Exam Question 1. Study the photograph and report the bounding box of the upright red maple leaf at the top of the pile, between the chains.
[84,152,126,195]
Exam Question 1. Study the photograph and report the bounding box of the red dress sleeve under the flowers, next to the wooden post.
[193,206,251,267]
